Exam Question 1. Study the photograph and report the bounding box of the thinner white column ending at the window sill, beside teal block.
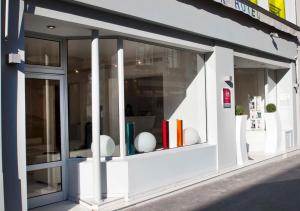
[118,39,126,158]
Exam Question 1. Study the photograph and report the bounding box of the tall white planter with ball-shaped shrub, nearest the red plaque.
[235,105,248,165]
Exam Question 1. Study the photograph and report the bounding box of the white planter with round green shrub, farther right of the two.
[265,103,281,154]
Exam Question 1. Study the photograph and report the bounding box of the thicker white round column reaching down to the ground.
[91,30,102,203]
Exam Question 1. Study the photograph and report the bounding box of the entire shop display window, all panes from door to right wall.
[68,39,207,157]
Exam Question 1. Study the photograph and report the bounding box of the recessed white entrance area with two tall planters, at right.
[234,56,296,164]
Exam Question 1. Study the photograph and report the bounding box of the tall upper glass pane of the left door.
[26,78,61,165]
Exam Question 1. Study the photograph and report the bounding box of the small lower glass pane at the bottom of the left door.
[27,167,62,198]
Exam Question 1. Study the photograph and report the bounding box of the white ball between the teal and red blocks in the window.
[134,132,156,152]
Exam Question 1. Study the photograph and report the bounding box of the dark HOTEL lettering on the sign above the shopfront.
[215,0,260,19]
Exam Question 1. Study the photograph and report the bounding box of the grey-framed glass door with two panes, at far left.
[25,74,66,208]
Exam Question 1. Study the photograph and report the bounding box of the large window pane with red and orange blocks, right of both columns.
[124,41,206,154]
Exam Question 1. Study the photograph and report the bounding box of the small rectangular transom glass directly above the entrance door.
[25,37,60,67]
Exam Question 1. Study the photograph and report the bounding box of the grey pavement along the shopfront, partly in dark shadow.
[126,155,300,211]
